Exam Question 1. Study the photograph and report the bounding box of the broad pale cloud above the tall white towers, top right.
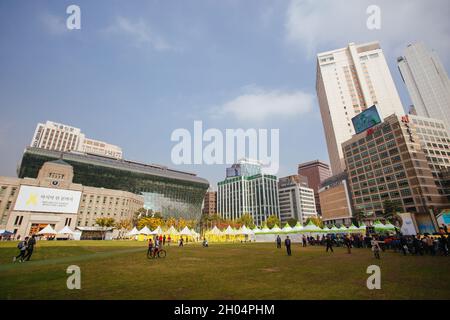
[285,0,450,62]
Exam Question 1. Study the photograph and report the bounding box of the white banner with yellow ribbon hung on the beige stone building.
[14,186,81,213]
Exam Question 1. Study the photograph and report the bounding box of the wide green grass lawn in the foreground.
[0,241,450,299]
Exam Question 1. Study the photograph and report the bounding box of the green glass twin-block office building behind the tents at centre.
[217,159,280,226]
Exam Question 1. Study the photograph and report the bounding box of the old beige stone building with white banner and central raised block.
[0,160,144,238]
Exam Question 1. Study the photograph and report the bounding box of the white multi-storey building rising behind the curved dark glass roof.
[30,121,122,159]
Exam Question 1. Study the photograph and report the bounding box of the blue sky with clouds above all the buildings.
[0,0,450,187]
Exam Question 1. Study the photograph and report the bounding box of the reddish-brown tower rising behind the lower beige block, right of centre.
[298,160,331,215]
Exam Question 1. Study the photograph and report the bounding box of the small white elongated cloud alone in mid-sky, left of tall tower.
[211,87,315,122]
